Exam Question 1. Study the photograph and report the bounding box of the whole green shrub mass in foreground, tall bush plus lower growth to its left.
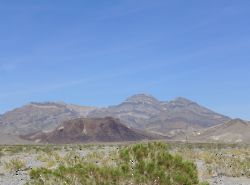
[27,142,204,185]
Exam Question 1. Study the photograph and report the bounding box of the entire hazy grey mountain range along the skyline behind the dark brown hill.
[0,94,248,142]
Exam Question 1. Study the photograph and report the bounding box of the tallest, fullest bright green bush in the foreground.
[120,143,198,185]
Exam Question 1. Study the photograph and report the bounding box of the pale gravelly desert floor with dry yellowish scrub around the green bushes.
[0,142,250,185]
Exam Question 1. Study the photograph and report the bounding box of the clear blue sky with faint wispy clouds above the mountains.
[0,0,250,120]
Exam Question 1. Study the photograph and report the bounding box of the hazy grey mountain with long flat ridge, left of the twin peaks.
[0,102,95,135]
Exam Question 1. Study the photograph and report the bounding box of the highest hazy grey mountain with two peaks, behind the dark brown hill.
[88,94,230,136]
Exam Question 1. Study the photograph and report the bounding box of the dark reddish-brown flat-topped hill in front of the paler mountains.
[22,117,159,144]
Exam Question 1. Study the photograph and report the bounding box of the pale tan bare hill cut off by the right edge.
[190,119,250,143]
